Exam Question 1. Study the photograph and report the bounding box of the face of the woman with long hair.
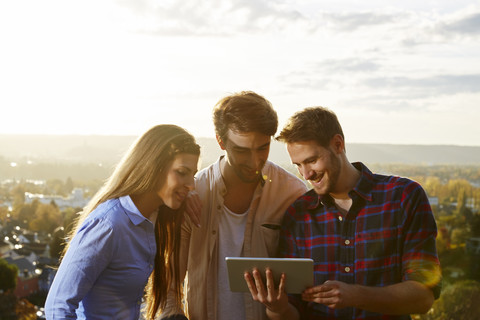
[156,153,198,209]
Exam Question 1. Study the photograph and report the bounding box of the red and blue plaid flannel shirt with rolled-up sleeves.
[280,163,441,319]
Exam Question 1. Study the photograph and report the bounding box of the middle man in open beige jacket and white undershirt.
[161,92,307,320]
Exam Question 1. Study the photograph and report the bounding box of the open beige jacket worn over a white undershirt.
[161,160,307,320]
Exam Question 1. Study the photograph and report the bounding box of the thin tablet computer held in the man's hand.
[225,257,313,293]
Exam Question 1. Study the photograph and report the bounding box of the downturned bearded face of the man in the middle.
[217,130,271,183]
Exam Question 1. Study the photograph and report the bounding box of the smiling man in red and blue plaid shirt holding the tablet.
[245,107,441,319]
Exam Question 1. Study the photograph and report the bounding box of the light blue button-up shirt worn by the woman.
[45,196,156,319]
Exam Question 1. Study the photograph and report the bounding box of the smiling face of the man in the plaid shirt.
[287,141,341,195]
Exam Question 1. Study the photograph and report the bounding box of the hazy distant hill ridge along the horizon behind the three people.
[0,135,480,167]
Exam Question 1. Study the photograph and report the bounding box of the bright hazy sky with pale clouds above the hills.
[0,0,480,146]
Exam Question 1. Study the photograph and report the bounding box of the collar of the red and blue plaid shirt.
[307,162,375,209]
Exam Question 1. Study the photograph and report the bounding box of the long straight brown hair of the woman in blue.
[63,124,200,319]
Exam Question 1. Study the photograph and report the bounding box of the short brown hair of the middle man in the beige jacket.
[213,91,278,141]
